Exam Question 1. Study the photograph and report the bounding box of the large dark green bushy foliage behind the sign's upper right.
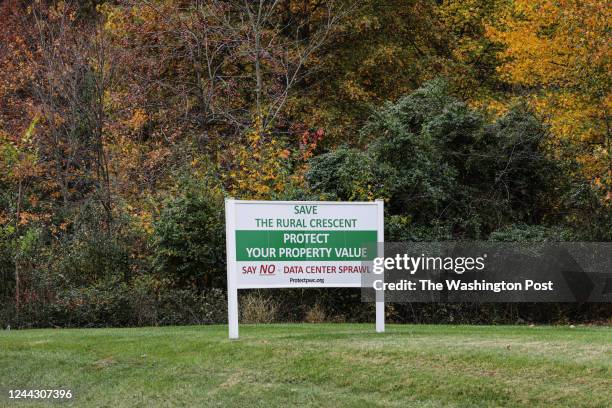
[306,80,559,239]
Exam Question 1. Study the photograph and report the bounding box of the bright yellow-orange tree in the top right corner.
[487,0,612,199]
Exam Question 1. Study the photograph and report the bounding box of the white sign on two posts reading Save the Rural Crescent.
[225,199,384,338]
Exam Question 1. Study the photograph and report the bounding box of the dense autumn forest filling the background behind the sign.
[0,0,612,327]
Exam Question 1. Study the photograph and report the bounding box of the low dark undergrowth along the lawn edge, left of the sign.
[0,277,227,328]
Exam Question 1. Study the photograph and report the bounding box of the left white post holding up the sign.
[225,198,238,339]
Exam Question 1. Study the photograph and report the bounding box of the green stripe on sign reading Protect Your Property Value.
[236,230,377,261]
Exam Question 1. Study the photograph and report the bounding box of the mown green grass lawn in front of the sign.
[0,324,612,408]
